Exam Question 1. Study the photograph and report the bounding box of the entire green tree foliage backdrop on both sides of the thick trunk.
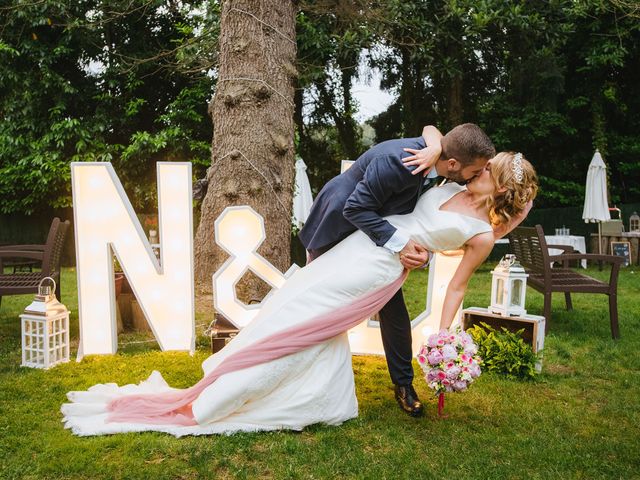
[0,0,640,213]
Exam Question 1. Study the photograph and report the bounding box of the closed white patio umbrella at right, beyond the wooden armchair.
[582,150,611,253]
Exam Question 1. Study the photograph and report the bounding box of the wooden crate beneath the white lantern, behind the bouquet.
[462,307,545,372]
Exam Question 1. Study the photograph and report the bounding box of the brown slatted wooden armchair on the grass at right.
[509,225,624,339]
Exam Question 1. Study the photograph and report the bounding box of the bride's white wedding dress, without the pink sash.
[61,183,491,436]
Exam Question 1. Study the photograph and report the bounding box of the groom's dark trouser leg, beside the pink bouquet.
[380,289,413,385]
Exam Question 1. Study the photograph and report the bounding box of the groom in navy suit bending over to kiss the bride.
[300,123,495,416]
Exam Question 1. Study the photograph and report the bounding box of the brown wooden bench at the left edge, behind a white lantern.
[0,217,69,304]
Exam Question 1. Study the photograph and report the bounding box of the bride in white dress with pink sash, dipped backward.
[61,152,537,436]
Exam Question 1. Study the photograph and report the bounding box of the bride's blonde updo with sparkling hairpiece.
[488,152,538,225]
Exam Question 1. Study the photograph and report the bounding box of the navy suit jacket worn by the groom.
[299,137,425,250]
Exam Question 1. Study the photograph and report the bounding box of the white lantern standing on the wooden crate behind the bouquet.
[489,254,529,317]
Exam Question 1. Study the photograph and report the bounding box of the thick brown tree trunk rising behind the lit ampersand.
[195,0,297,302]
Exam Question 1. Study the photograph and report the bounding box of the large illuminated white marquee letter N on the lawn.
[71,162,195,361]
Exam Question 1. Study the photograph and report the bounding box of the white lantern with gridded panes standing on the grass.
[20,277,69,369]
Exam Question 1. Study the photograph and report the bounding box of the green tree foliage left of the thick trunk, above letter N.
[0,0,217,213]
